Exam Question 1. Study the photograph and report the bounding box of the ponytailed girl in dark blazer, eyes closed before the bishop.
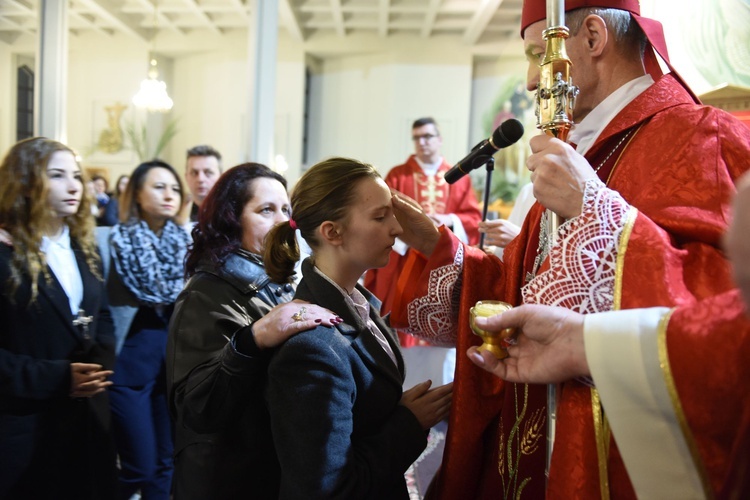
[264,158,452,499]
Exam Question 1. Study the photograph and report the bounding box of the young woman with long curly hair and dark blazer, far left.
[0,137,117,500]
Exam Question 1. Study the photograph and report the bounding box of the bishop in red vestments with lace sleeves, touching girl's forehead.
[391,0,750,498]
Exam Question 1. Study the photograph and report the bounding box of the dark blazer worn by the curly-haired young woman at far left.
[0,242,116,498]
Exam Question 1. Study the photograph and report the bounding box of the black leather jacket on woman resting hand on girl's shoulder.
[167,250,294,500]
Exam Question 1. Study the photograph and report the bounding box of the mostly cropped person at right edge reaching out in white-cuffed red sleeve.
[469,171,750,499]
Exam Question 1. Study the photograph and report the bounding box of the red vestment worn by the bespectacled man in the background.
[364,155,482,347]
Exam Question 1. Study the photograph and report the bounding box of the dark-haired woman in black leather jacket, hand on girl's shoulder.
[167,163,338,500]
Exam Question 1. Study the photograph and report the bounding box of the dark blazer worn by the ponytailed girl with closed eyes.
[265,259,427,500]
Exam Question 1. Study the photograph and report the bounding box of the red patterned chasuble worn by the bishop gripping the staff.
[392,75,750,499]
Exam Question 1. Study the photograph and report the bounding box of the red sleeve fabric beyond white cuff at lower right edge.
[667,290,750,494]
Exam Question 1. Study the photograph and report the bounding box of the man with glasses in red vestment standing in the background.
[365,117,482,387]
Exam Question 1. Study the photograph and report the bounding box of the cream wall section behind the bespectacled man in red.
[308,44,471,178]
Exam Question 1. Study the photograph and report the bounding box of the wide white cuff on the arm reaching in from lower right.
[583,307,704,499]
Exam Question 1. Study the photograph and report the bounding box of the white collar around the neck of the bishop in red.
[568,75,654,155]
